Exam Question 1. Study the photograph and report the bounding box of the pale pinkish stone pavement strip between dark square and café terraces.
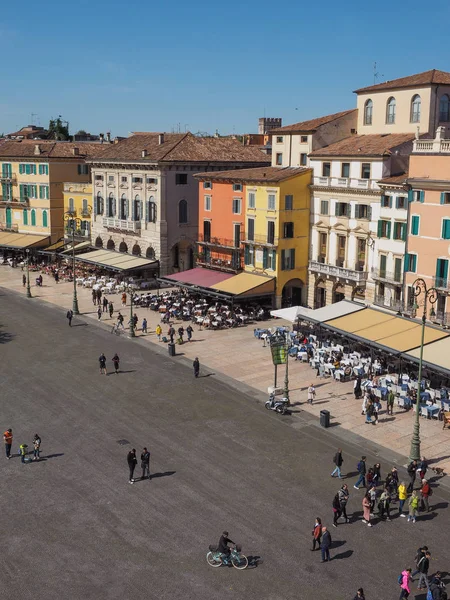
[0,266,450,473]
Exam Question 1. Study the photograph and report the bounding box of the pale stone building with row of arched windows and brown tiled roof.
[90,133,270,275]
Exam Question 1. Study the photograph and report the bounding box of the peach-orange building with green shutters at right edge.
[405,127,450,324]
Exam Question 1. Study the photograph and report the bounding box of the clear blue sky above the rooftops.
[0,0,450,136]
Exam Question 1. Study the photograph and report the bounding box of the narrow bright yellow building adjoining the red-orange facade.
[241,167,312,307]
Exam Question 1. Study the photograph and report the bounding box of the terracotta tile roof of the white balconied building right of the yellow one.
[309,133,414,158]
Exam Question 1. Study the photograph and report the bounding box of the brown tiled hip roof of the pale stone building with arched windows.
[89,133,270,164]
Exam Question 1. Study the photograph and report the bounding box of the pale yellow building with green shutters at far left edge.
[0,140,99,247]
